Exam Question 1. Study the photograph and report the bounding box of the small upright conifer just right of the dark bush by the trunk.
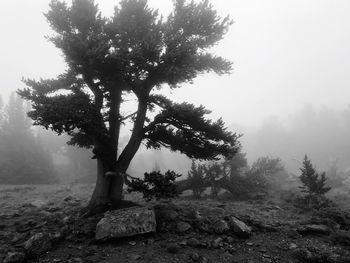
[187,160,207,198]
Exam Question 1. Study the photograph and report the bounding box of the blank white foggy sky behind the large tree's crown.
[0,0,350,126]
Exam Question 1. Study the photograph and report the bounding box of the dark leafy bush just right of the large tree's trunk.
[128,170,181,201]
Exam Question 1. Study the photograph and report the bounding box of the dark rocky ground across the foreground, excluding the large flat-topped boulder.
[0,185,350,263]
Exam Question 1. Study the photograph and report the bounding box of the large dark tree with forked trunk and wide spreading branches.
[19,0,239,213]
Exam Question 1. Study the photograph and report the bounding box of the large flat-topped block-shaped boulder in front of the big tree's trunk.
[95,207,156,240]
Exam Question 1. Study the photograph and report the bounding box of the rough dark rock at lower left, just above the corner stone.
[24,233,52,255]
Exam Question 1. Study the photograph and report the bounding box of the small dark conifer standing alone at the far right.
[299,155,331,208]
